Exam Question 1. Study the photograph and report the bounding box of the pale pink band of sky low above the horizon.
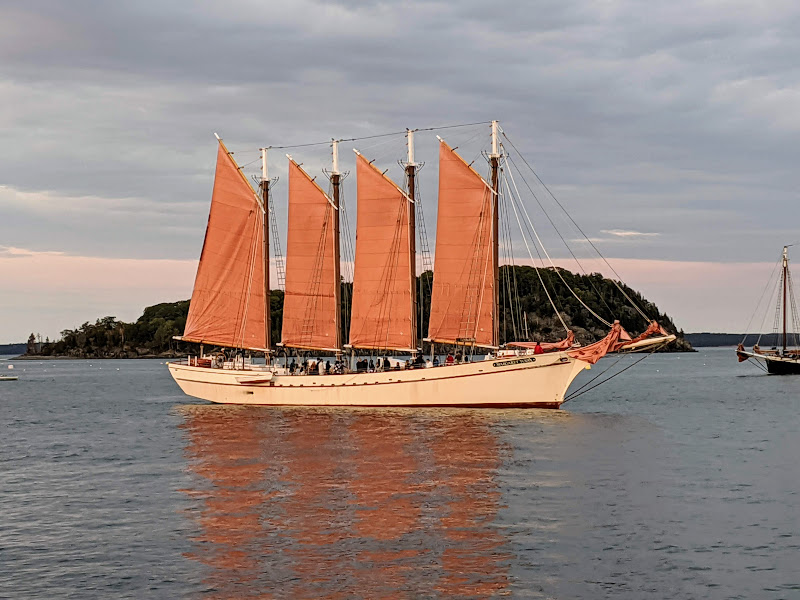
[0,248,774,343]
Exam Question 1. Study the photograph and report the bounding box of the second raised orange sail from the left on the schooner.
[281,159,341,350]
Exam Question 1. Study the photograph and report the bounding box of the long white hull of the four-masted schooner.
[169,352,589,408]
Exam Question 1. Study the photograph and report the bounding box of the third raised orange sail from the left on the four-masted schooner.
[350,154,417,350]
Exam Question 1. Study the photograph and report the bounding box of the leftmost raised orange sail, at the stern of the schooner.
[181,141,269,350]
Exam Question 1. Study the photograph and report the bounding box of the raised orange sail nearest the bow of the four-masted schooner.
[428,142,496,347]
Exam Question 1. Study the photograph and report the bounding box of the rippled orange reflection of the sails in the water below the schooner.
[183,406,510,598]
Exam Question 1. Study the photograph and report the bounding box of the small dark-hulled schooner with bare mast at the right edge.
[736,246,800,375]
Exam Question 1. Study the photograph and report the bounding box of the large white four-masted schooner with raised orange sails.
[169,121,675,408]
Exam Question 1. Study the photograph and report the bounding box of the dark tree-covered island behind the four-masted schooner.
[32,266,691,358]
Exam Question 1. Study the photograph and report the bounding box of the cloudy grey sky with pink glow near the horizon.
[0,0,800,343]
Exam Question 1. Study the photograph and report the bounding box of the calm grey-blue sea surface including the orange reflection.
[0,349,800,599]
